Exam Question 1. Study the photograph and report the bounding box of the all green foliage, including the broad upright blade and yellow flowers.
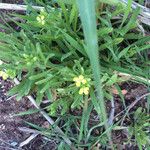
[0,0,150,149]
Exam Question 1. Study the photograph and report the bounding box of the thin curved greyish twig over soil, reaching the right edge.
[121,93,150,125]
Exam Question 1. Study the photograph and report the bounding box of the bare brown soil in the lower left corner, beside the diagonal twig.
[0,78,55,150]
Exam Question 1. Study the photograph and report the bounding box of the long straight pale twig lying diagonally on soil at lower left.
[14,78,72,146]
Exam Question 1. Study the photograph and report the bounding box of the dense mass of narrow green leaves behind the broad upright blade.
[0,1,150,115]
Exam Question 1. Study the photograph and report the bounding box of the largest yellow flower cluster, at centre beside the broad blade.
[73,75,91,95]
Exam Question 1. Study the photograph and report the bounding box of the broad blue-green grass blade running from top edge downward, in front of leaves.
[77,0,110,145]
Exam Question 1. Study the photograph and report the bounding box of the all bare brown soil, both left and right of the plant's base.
[0,78,147,150]
